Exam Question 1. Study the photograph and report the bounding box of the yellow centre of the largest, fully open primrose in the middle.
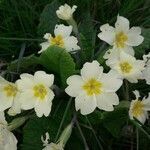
[83,79,102,96]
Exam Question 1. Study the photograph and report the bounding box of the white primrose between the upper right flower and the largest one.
[107,51,145,83]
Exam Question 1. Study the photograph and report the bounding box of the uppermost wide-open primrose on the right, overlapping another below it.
[98,15,144,56]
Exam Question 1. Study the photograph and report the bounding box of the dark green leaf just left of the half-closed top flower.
[38,0,60,36]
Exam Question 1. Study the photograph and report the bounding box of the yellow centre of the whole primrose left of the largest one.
[33,84,47,100]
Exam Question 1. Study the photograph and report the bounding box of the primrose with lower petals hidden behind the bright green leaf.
[38,24,80,53]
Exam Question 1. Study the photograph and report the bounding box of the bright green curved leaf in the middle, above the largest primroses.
[40,46,75,87]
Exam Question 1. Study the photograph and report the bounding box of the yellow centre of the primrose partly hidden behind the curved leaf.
[50,35,64,48]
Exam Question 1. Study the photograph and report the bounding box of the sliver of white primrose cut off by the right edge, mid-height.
[143,53,150,85]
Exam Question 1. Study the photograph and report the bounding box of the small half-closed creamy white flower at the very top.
[56,4,77,20]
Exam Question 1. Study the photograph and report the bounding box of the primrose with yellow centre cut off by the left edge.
[0,76,18,111]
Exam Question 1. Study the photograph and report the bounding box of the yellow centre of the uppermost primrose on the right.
[116,32,128,48]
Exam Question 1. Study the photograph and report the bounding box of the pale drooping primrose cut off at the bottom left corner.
[0,112,17,150]
